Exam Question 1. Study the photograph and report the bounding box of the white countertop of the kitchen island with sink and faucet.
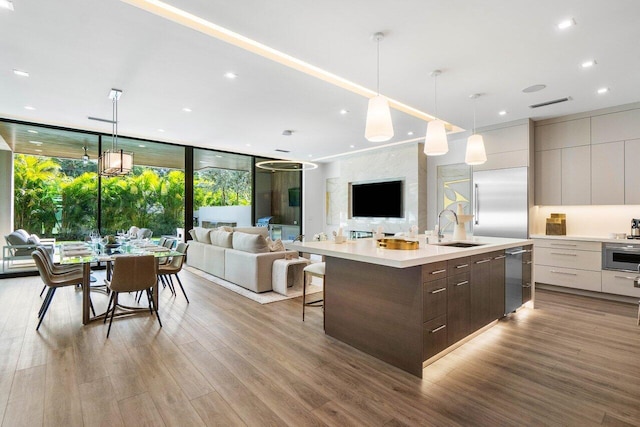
[285,235,533,268]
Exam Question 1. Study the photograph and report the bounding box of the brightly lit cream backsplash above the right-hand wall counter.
[530,205,640,237]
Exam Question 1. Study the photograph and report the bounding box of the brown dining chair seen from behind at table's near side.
[104,255,162,338]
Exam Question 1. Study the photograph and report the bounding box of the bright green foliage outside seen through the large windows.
[14,154,251,240]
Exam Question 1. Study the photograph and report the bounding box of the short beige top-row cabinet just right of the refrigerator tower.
[534,117,591,151]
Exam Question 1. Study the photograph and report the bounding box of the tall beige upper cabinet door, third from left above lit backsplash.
[591,141,625,205]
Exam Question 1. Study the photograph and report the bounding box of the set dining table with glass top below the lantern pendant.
[58,241,184,325]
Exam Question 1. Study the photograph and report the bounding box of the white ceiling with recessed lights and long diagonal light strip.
[0,0,640,161]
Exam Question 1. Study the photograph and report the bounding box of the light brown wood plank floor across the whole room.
[0,271,640,426]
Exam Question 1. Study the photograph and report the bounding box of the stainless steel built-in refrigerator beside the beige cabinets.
[473,167,529,239]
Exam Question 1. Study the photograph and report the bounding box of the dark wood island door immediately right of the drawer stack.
[447,273,471,345]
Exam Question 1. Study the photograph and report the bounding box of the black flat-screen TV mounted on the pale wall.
[351,180,404,218]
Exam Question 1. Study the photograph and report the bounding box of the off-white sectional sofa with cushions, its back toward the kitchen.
[187,227,286,292]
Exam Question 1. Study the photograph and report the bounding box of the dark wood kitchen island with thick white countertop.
[286,236,533,377]
